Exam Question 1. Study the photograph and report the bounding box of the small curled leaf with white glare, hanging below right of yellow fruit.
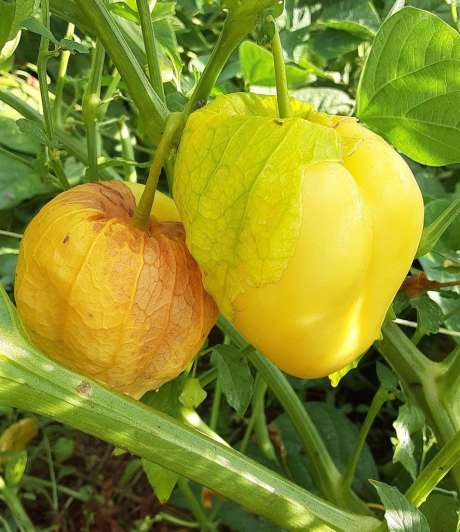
[392,403,425,479]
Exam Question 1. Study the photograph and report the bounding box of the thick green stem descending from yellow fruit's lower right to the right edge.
[377,321,460,492]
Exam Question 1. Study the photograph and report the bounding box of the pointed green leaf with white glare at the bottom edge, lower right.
[370,480,430,532]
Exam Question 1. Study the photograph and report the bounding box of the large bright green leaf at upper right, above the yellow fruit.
[357,7,460,166]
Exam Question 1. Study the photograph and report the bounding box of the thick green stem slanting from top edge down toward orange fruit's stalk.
[75,0,168,144]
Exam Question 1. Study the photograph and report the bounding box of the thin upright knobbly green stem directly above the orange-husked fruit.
[82,39,105,181]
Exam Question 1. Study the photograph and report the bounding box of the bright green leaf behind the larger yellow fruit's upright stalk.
[240,41,314,87]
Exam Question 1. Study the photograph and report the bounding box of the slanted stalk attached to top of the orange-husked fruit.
[133,113,184,231]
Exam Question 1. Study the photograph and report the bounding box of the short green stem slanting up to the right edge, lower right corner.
[406,431,460,507]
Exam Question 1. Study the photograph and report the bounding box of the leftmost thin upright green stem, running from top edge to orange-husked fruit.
[37,0,70,189]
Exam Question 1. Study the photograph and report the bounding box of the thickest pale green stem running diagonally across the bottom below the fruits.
[0,287,380,532]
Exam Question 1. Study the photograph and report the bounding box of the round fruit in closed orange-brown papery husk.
[15,182,217,398]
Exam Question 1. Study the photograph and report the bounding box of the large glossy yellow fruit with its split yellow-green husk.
[174,94,423,378]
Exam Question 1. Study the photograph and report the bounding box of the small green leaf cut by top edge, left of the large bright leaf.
[321,0,380,38]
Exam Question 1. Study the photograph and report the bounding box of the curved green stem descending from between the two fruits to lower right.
[219,318,369,513]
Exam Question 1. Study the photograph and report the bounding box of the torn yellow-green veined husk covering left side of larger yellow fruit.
[174,94,342,316]
